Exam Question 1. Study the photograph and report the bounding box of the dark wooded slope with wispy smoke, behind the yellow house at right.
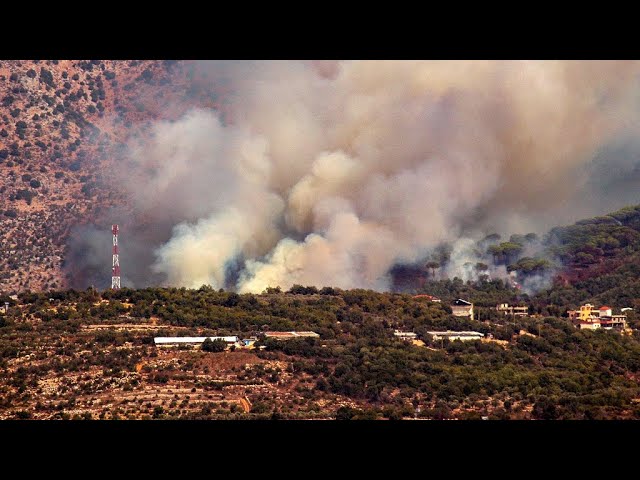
[404,206,640,315]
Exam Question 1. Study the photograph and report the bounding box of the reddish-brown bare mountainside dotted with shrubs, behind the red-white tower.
[0,60,229,292]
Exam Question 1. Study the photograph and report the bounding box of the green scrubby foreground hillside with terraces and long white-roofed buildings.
[0,287,640,419]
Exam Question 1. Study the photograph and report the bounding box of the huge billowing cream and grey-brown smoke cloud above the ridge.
[81,61,640,292]
